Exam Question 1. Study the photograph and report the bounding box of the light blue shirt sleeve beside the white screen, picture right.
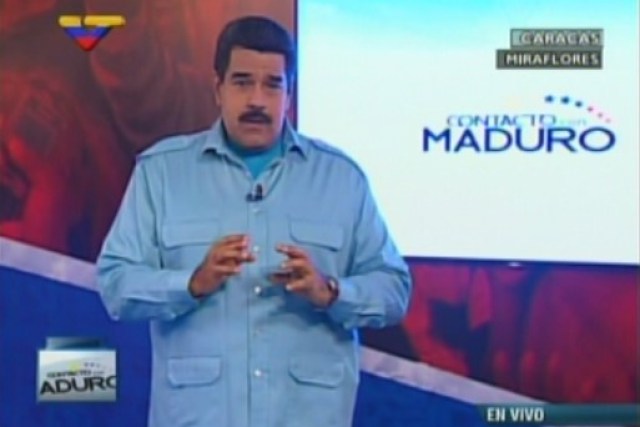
[328,174,412,329]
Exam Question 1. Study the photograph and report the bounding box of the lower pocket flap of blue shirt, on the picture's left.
[167,357,222,387]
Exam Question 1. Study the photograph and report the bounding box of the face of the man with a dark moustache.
[216,48,290,148]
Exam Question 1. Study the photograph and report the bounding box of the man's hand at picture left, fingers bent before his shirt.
[189,234,256,298]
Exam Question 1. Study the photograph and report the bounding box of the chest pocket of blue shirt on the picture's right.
[289,219,345,275]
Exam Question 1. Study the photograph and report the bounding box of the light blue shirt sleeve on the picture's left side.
[97,159,199,320]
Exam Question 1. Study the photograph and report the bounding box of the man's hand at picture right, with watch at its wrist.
[272,245,334,307]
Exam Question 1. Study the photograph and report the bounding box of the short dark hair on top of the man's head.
[213,16,296,90]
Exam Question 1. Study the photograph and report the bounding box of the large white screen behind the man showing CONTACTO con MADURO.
[298,0,640,265]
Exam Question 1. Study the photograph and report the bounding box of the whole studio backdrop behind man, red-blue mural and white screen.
[0,0,640,427]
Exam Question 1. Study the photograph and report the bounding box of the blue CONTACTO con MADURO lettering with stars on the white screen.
[422,94,617,154]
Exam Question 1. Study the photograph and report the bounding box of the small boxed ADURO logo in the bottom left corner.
[37,337,117,402]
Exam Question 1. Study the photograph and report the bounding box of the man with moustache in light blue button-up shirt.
[98,17,411,427]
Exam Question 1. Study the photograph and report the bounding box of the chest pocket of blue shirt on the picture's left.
[160,220,220,269]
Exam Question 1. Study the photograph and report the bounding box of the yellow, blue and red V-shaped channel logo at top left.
[58,15,125,52]
